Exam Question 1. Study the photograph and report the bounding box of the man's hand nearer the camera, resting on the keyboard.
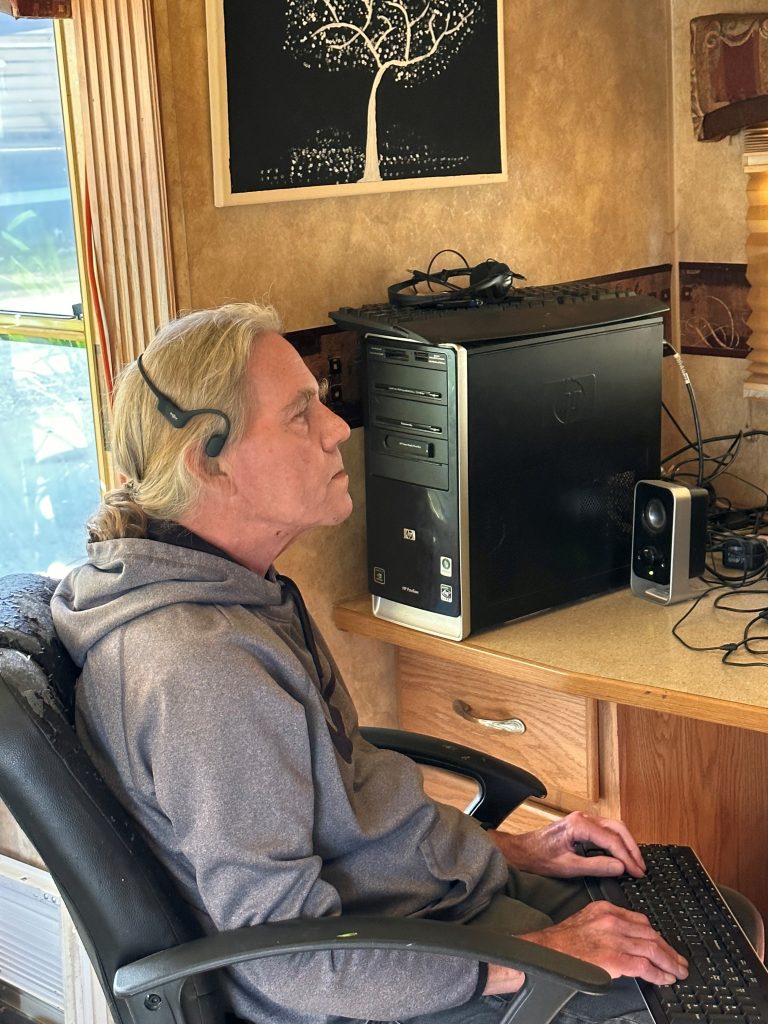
[519,900,688,985]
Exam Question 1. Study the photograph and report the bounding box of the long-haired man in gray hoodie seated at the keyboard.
[53,304,686,1024]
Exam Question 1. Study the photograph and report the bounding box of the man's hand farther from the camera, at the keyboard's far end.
[488,811,645,879]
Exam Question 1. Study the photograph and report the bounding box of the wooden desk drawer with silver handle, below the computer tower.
[397,651,599,810]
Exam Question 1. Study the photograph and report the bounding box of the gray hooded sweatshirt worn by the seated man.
[52,540,508,1024]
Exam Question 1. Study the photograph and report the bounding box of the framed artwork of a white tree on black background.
[206,0,507,206]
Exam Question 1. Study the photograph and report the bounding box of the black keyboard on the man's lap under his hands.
[586,844,768,1024]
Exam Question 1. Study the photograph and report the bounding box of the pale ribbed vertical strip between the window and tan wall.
[73,0,175,377]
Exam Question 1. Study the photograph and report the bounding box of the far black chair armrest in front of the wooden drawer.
[360,726,547,828]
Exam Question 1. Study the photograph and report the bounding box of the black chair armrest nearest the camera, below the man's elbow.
[113,915,610,1024]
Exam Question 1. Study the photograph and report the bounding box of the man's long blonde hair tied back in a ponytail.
[87,302,281,541]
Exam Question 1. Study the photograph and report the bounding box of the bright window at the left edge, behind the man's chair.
[0,14,99,577]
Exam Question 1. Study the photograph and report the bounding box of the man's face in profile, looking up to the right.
[220,333,352,546]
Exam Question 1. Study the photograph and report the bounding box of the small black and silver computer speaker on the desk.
[630,480,709,604]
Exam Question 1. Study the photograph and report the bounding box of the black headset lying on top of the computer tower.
[387,249,525,308]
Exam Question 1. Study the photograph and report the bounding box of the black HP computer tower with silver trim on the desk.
[364,297,664,640]
